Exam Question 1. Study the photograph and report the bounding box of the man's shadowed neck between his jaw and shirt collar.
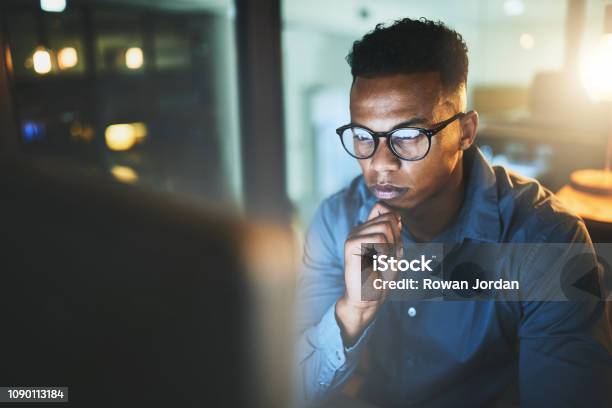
[402,156,465,242]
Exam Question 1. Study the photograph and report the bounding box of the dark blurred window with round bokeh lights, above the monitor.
[0,0,240,205]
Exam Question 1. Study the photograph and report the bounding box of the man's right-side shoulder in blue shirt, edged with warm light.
[493,166,590,243]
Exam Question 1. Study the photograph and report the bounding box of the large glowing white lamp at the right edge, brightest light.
[580,34,612,102]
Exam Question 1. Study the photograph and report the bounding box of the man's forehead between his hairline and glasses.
[350,72,443,121]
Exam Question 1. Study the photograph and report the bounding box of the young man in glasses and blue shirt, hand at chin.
[297,19,612,407]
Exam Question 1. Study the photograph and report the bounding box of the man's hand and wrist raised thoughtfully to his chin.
[336,203,402,346]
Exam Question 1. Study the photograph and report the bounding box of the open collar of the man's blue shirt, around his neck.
[358,146,501,242]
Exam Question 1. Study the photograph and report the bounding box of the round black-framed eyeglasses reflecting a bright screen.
[336,112,466,161]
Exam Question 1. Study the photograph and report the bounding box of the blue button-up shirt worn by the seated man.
[296,147,612,407]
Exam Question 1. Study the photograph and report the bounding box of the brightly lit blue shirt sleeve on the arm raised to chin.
[293,198,374,406]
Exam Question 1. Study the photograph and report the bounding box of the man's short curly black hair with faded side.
[346,18,468,91]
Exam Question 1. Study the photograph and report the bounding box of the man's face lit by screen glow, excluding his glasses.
[350,73,462,209]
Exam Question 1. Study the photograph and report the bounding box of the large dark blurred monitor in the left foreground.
[0,158,289,407]
